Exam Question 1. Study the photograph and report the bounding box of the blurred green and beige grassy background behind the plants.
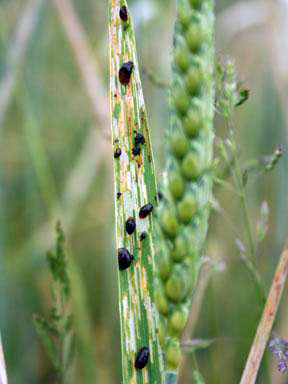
[0,0,288,384]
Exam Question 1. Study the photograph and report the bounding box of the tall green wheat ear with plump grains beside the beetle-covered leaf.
[155,0,214,370]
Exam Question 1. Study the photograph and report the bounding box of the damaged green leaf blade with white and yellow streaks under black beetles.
[109,0,162,384]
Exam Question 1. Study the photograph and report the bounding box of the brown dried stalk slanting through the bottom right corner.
[240,241,288,384]
